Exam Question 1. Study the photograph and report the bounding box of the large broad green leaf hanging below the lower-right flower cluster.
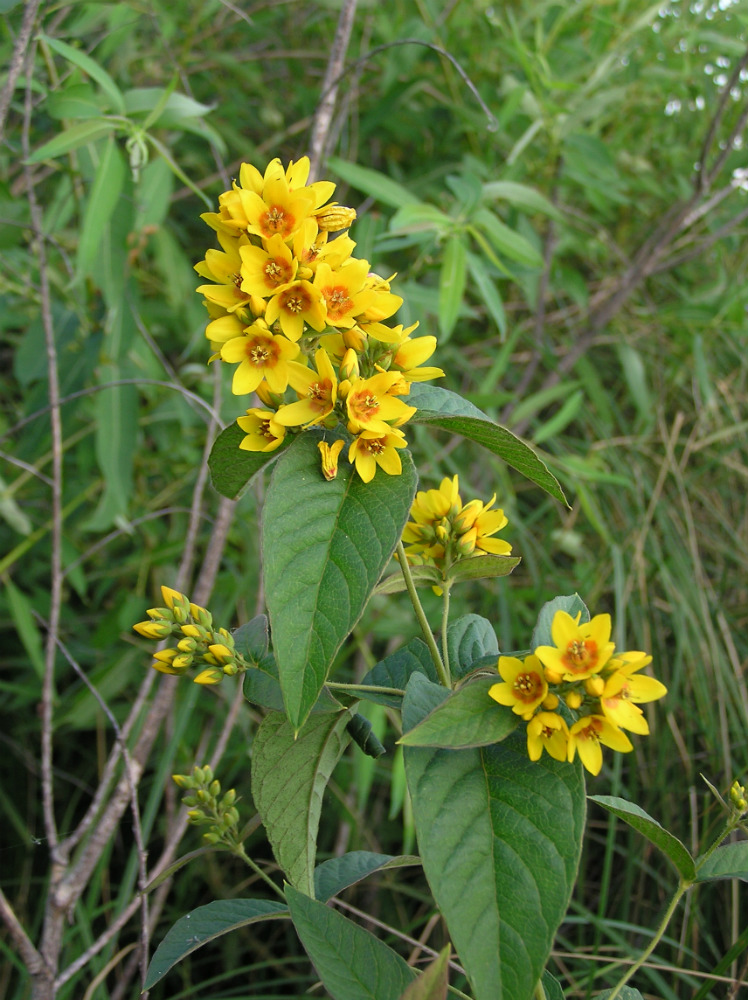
[403,691,585,1000]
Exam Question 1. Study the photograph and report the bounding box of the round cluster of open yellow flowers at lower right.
[488,611,667,774]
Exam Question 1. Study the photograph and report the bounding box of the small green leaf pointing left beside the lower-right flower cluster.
[398,674,519,750]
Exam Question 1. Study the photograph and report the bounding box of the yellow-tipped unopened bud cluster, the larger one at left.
[133,587,248,684]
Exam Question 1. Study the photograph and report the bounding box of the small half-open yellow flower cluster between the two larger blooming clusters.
[403,476,512,594]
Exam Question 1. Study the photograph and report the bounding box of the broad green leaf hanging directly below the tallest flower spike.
[262,431,416,728]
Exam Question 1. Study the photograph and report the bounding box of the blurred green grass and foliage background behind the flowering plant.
[0,0,748,1000]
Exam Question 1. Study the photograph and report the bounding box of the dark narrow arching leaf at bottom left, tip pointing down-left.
[143,899,288,990]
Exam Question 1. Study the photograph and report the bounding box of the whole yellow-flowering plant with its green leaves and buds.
[135,159,746,1000]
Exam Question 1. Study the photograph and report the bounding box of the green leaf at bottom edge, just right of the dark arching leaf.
[286,886,416,1000]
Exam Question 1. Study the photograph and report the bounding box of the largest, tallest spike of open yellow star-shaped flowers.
[195,157,444,482]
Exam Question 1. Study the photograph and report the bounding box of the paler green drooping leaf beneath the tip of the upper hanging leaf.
[252,709,353,896]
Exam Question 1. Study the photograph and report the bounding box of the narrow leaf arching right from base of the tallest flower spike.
[408,383,568,506]
